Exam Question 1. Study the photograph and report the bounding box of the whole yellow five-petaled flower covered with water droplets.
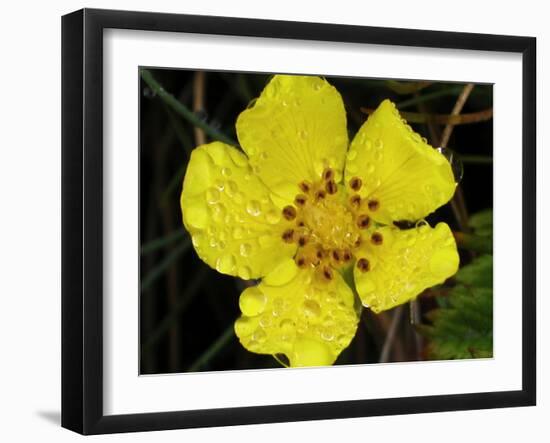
[181,75,459,366]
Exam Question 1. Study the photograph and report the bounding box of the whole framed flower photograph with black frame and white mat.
[62,9,536,434]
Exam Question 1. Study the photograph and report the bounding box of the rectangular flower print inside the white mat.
[136,67,493,375]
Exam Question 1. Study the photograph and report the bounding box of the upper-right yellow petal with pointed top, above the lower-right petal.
[345,100,456,224]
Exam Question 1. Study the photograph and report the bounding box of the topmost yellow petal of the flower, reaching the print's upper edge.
[237,75,348,201]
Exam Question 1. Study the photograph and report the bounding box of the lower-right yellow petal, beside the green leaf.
[354,223,459,313]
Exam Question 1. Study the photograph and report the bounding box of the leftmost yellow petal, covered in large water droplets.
[181,142,296,280]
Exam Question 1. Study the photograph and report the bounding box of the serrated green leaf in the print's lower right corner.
[417,255,493,360]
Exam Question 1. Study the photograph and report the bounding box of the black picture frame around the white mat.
[62,9,536,434]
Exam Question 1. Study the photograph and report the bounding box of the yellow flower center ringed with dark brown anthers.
[282,168,382,280]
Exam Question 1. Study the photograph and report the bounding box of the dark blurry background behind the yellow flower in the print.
[139,69,493,374]
